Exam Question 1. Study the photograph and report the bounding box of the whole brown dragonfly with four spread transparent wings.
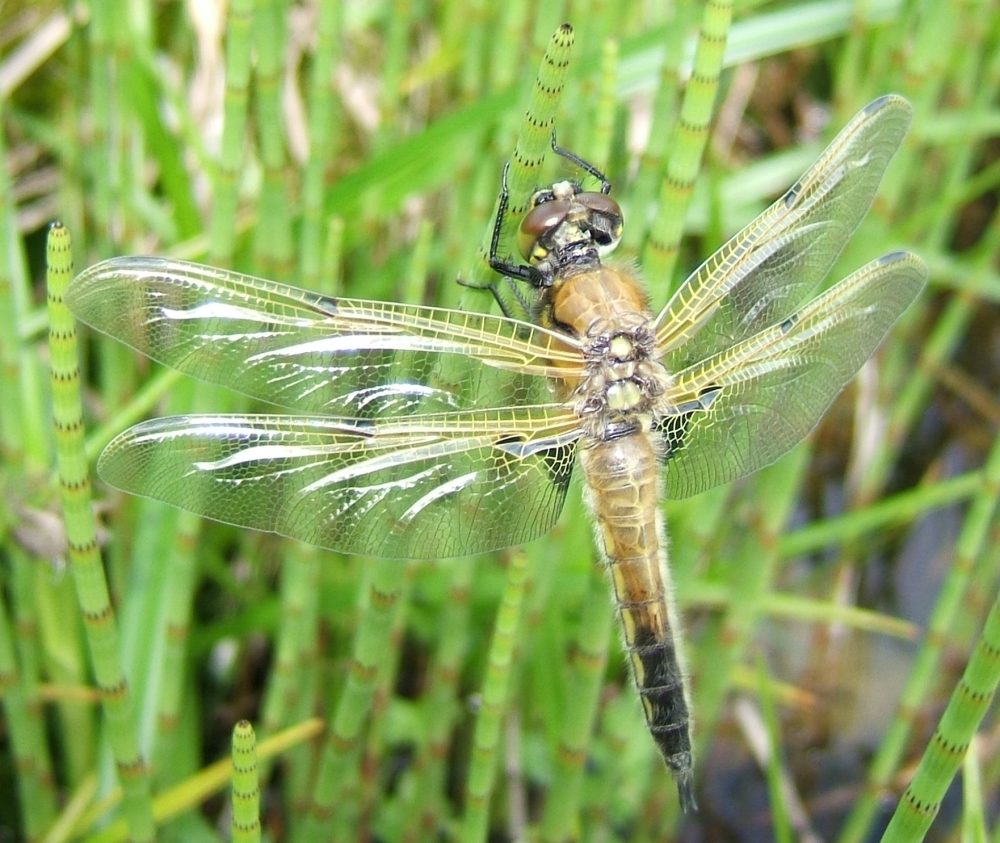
[67,95,927,810]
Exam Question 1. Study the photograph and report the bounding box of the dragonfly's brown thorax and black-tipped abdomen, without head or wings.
[547,265,694,808]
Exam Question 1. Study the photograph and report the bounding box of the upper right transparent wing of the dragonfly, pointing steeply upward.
[656,96,911,371]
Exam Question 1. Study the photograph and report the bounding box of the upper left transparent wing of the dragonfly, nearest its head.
[66,257,582,418]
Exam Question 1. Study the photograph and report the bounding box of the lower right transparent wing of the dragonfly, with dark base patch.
[656,252,927,497]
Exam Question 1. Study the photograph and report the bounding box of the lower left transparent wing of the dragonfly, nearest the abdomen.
[98,405,580,559]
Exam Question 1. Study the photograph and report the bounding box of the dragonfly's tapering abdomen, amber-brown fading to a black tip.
[580,431,696,810]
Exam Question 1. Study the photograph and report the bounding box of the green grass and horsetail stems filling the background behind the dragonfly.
[0,0,1000,843]
